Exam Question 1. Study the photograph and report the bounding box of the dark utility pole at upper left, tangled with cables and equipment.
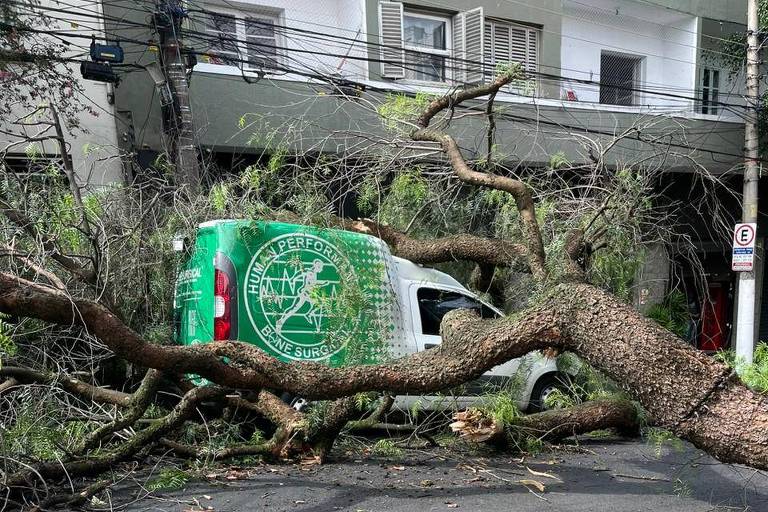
[155,0,200,194]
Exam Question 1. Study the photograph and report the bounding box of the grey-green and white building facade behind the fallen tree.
[103,0,768,343]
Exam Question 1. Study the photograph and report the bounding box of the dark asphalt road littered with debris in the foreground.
[113,438,768,512]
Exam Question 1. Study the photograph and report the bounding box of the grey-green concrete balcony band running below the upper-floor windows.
[183,73,743,173]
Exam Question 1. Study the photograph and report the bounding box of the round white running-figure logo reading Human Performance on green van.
[244,233,359,361]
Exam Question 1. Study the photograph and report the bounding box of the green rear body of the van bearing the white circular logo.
[179,220,403,366]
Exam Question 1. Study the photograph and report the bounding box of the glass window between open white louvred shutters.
[403,13,450,82]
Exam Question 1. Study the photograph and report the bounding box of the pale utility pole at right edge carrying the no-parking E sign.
[736,0,760,363]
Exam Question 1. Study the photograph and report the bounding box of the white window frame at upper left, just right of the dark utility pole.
[202,4,284,74]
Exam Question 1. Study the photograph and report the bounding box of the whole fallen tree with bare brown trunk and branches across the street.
[0,63,768,504]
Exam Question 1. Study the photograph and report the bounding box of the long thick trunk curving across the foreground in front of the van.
[0,274,768,468]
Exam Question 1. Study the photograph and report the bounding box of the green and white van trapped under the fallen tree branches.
[174,220,562,409]
